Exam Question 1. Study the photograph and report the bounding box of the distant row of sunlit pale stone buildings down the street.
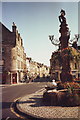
[26,58,49,79]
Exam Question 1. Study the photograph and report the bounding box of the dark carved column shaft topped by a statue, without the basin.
[59,10,72,82]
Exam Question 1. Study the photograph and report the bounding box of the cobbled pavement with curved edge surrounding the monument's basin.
[16,88,80,120]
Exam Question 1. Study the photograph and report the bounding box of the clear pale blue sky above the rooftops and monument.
[1,2,78,66]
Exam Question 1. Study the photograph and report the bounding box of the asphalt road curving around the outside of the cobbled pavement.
[2,82,47,120]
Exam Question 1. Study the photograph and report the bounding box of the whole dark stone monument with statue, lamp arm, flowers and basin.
[43,10,80,106]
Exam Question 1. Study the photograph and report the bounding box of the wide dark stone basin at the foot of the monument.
[43,89,80,107]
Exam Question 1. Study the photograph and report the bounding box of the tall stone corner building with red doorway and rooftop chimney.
[0,23,26,84]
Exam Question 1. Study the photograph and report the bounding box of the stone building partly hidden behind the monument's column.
[50,47,80,80]
